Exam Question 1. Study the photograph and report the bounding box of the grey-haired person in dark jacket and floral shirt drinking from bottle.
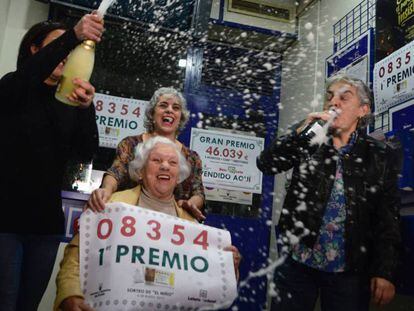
[257,74,401,311]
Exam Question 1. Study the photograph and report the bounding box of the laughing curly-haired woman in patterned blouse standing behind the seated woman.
[87,87,205,221]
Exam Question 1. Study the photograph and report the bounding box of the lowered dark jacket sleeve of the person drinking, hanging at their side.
[371,147,401,283]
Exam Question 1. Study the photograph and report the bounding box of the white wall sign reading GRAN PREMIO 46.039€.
[190,128,264,193]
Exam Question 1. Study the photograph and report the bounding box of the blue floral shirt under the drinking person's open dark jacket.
[292,132,357,272]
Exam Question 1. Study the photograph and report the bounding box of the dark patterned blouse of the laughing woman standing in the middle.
[106,134,204,201]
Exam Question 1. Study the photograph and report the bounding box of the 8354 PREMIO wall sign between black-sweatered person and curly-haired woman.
[94,93,148,148]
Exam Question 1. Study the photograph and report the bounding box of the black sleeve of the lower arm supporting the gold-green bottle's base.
[72,103,99,162]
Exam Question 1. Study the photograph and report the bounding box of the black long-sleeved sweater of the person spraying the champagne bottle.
[0,30,98,234]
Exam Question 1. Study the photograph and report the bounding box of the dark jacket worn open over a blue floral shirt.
[257,126,400,281]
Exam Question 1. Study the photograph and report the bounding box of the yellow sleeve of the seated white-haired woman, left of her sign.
[53,235,84,311]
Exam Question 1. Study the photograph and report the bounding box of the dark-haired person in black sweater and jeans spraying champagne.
[0,14,103,311]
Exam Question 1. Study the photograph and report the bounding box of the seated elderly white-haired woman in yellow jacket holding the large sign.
[55,136,240,311]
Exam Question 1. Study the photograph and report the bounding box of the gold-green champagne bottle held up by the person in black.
[55,40,95,106]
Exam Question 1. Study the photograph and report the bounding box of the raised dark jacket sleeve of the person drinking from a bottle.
[256,123,311,175]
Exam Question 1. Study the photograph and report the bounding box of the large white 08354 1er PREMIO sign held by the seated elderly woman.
[80,203,237,311]
